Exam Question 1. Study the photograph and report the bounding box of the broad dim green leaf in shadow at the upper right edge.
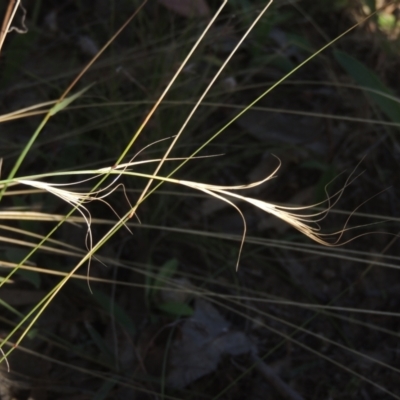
[334,51,400,123]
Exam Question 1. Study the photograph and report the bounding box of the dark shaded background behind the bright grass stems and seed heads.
[0,0,400,400]
